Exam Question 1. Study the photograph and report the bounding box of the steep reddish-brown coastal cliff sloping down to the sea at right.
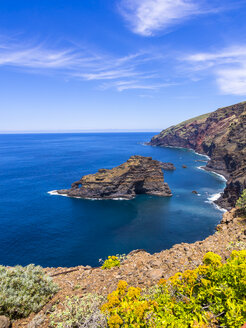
[149,102,246,209]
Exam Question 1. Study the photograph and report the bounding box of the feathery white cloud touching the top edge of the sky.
[119,0,224,36]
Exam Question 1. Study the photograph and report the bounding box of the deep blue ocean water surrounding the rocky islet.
[0,133,225,266]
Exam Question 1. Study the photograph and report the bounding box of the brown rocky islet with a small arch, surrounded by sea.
[57,156,172,199]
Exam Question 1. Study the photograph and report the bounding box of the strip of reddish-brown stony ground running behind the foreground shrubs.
[13,209,246,328]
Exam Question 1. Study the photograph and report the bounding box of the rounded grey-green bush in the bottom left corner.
[0,264,58,319]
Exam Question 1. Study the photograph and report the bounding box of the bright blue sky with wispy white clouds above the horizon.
[0,0,246,133]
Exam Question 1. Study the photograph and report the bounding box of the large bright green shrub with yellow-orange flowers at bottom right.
[101,250,246,328]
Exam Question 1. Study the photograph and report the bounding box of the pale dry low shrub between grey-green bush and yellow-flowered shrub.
[50,294,107,328]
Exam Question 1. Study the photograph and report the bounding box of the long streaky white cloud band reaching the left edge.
[0,42,173,91]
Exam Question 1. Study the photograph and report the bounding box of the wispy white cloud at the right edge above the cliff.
[185,46,246,96]
